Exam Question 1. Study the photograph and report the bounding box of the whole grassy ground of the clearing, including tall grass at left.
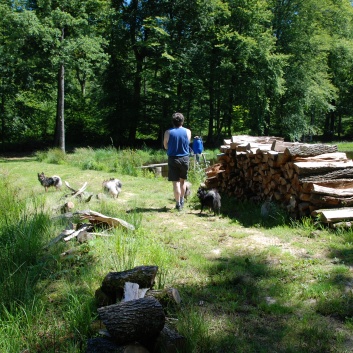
[0,144,353,353]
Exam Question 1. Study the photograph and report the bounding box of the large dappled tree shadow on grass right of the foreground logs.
[178,255,339,353]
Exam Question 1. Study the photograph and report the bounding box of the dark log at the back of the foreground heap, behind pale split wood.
[101,266,158,302]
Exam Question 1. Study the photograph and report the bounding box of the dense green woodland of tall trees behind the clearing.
[0,0,353,150]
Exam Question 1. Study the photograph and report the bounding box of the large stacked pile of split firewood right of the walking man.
[206,135,353,223]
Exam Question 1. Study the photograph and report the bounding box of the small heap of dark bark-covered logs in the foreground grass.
[86,266,186,353]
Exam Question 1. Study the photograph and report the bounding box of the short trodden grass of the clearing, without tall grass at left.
[0,159,353,353]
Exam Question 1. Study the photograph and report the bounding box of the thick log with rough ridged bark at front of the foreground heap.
[98,297,165,344]
